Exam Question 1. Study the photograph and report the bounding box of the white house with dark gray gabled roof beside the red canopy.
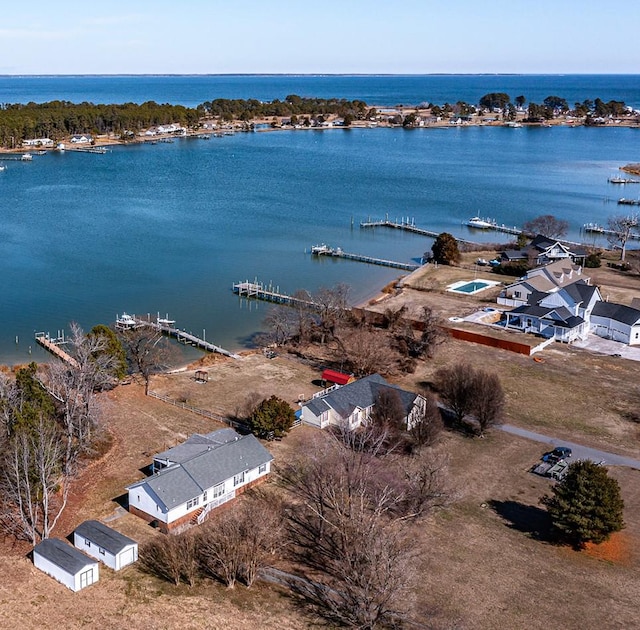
[300,374,425,430]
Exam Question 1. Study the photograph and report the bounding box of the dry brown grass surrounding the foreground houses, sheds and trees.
[0,260,640,630]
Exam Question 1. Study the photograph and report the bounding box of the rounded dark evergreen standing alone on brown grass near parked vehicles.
[540,460,624,548]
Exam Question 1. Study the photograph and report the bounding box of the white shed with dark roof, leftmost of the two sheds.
[33,538,100,591]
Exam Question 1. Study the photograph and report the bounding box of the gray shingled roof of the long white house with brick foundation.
[127,431,273,510]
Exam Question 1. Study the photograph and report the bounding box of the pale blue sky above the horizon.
[0,0,640,75]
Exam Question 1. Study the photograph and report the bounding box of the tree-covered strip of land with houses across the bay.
[0,92,638,149]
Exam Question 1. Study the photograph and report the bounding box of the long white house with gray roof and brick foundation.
[127,429,273,533]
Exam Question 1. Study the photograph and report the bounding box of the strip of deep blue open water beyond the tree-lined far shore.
[0,75,640,108]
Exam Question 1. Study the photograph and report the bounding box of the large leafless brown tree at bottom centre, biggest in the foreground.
[279,438,430,628]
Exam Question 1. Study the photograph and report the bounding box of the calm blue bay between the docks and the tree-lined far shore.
[0,79,640,363]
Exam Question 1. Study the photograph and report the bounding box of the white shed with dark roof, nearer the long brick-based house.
[73,521,138,571]
